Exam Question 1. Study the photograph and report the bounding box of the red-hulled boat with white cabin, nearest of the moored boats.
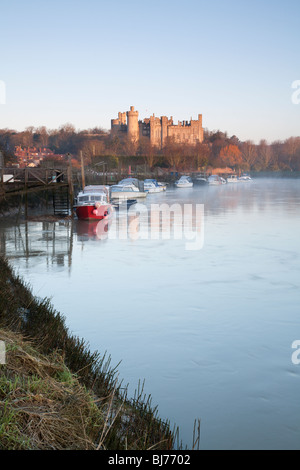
[74,185,114,220]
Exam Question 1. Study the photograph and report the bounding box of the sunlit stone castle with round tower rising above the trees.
[111,106,203,148]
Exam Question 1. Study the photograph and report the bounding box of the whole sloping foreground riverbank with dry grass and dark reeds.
[0,257,180,450]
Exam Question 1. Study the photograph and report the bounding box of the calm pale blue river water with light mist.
[0,179,300,449]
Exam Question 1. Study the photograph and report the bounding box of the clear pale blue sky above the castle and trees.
[0,0,300,141]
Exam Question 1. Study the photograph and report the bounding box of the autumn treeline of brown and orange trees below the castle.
[0,124,300,171]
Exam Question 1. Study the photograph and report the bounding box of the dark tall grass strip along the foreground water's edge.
[0,257,181,450]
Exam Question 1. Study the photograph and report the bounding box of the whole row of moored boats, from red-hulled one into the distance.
[74,175,251,220]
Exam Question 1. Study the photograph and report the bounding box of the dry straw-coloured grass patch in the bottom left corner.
[0,330,105,450]
